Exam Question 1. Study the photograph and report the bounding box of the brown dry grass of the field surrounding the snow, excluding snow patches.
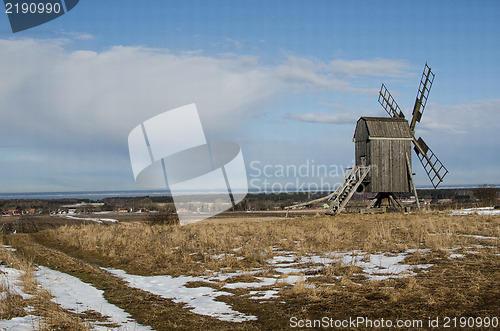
[1,212,500,329]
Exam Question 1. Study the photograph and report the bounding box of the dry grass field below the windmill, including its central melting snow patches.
[1,212,500,330]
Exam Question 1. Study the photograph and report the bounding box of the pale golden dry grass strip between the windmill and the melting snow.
[40,213,500,275]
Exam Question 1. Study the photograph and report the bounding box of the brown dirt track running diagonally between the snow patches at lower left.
[8,232,256,330]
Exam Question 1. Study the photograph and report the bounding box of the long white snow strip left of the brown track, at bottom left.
[35,266,152,330]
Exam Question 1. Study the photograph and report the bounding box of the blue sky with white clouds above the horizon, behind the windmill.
[0,0,500,192]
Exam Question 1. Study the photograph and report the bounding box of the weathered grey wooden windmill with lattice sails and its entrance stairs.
[287,63,448,215]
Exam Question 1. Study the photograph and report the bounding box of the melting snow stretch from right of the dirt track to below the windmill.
[103,249,432,322]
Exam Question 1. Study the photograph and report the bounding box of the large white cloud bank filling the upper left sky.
[0,39,410,147]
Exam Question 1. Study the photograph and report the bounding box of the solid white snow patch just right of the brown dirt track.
[103,268,257,322]
